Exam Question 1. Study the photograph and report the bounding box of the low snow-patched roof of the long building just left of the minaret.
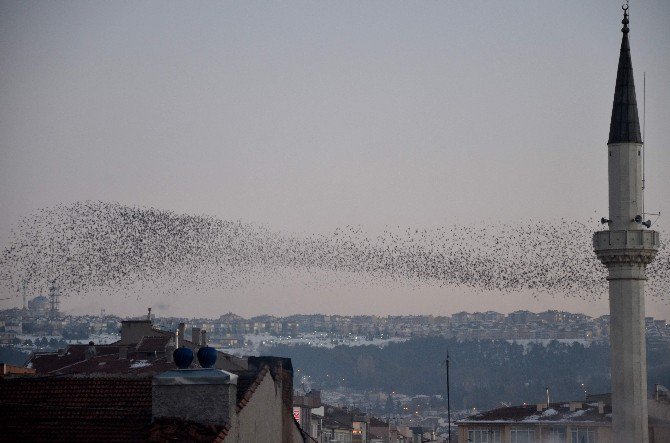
[460,403,612,423]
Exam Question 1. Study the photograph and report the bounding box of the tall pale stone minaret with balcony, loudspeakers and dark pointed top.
[593,5,659,443]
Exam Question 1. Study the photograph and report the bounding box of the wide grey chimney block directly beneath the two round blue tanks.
[151,348,237,426]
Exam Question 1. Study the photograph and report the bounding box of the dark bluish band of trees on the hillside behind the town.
[262,337,670,409]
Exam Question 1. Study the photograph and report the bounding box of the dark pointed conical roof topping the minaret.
[607,8,642,144]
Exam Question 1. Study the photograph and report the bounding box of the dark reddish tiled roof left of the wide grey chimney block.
[0,377,151,442]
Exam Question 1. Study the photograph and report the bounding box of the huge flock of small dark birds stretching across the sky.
[0,202,670,298]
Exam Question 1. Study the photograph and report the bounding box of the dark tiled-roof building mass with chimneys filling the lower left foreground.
[5,320,309,443]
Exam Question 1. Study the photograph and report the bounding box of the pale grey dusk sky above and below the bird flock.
[0,0,670,320]
